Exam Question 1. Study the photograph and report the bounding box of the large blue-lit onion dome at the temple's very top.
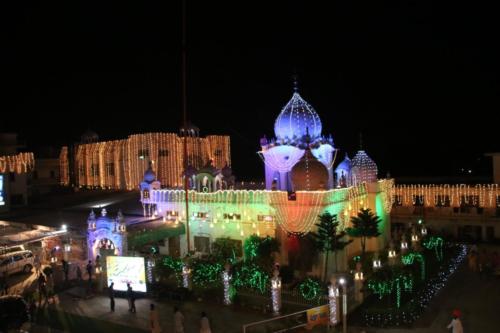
[274,92,321,140]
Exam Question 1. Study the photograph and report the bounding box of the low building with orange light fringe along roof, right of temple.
[391,184,500,241]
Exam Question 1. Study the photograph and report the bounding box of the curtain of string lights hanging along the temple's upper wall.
[148,180,376,236]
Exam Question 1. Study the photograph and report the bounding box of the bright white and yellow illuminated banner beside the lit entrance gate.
[106,256,146,293]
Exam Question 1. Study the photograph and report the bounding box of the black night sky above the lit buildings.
[0,0,500,179]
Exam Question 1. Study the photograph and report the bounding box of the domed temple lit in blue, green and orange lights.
[140,83,394,275]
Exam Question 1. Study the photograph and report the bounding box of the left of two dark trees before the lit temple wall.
[311,212,352,280]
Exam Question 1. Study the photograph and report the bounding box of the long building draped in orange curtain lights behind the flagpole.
[59,126,231,190]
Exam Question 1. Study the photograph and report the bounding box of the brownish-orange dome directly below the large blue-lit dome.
[292,148,328,191]
